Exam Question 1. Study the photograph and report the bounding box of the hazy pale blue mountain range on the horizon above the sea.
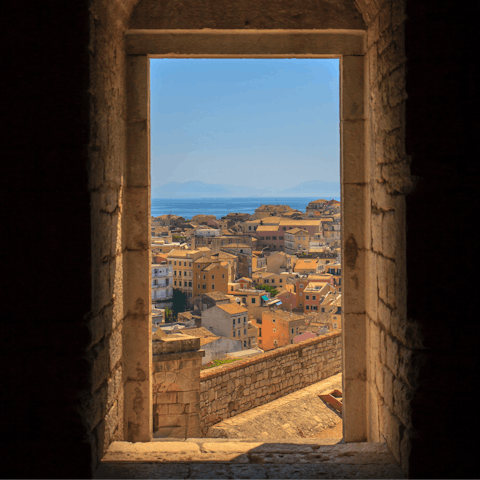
[152,180,340,198]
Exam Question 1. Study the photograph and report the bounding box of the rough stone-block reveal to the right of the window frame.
[352,0,416,473]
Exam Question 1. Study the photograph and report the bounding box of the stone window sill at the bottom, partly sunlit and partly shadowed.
[94,438,405,480]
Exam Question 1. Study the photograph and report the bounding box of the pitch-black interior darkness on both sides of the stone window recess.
[0,0,479,479]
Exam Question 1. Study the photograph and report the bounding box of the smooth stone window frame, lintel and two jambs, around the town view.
[123,30,369,442]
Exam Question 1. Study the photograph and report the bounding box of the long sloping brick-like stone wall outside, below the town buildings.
[200,332,342,435]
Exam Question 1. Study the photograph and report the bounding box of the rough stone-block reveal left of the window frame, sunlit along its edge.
[86,0,142,469]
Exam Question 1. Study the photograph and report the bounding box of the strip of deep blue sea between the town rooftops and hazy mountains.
[152,197,340,218]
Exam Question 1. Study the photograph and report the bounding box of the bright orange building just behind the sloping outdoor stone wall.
[257,310,305,350]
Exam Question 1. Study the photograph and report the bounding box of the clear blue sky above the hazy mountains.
[150,59,340,192]
